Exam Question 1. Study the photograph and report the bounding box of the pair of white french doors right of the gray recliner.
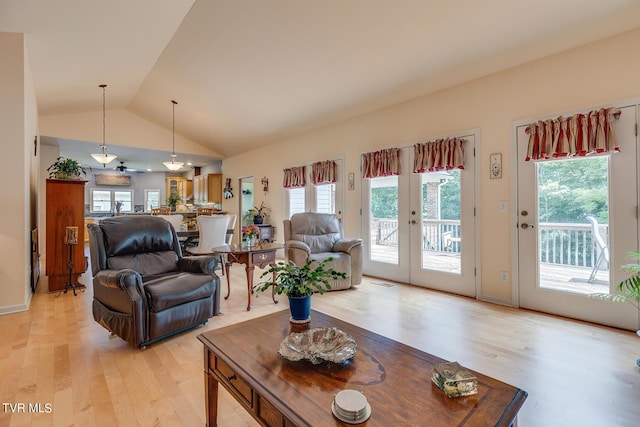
[362,133,478,297]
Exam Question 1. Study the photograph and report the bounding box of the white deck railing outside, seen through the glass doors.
[371,219,609,269]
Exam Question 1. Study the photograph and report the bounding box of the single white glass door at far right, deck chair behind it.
[514,105,638,328]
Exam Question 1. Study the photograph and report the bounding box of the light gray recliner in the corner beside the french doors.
[284,212,362,291]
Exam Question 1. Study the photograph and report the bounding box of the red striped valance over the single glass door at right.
[525,107,620,161]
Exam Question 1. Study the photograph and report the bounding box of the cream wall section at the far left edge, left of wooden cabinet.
[0,33,38,313]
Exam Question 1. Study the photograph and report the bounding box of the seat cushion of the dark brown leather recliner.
[144,273,215,312]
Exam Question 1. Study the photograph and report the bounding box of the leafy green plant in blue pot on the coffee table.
[254,258,347,321]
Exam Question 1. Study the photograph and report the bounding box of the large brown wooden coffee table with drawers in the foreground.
[198,310,527,427]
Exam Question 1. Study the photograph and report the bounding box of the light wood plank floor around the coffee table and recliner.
[0,254,640,427]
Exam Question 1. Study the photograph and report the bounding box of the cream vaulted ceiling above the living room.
[0,0,640,170]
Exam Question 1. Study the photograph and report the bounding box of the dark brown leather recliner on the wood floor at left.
[88,215,220,348]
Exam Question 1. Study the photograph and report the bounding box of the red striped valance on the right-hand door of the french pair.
[413,138,464,173]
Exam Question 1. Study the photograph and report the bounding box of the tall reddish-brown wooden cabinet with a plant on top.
[46,179,87,292]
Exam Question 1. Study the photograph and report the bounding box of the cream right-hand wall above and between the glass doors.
[223,25,640,303]
